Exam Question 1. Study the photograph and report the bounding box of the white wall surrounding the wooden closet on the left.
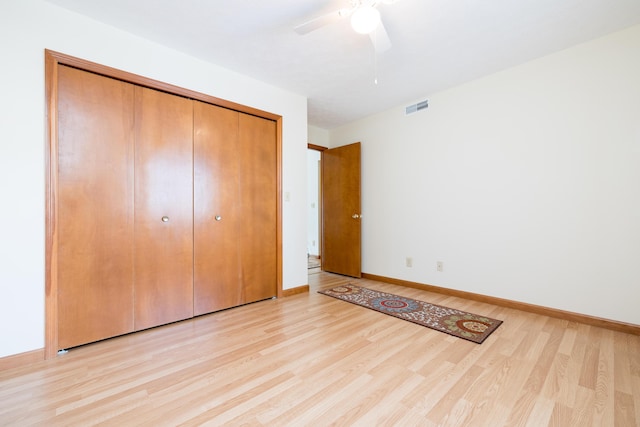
[0,0,307,357]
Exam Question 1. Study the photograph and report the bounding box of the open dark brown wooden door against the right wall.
[322,142,361,277]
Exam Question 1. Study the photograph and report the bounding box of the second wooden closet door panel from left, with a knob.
[135,87,193,330]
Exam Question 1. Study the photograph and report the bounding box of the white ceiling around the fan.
[48,0,640,129]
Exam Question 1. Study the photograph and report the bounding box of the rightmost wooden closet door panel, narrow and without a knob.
[238,113,277,302]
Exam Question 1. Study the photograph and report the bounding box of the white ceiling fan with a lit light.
[294,0,399,53]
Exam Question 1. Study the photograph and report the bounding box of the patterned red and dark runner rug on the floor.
[318,284,502,344]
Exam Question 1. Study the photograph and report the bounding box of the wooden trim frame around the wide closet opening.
[44,49,283,359]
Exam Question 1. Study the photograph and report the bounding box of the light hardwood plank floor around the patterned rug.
[0,271,640,427]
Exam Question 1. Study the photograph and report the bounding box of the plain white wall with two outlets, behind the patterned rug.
[331,26,640,325]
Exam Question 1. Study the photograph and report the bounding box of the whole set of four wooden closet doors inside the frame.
[53,64,278,349]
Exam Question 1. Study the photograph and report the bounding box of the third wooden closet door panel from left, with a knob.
[194,102,244,315]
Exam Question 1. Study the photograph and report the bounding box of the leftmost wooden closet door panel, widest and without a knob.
[57,65,134,348]
